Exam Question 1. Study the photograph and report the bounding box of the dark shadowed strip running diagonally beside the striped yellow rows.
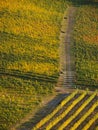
[17,94,68,130]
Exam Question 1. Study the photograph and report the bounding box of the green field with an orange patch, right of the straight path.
[72,3,98,88]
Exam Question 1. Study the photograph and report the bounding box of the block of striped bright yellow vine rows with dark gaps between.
[32,90,98,130]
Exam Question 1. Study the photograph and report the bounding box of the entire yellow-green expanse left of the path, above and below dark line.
[0,0,67,130]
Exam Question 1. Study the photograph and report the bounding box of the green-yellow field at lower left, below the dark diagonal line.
[0,76,53,130]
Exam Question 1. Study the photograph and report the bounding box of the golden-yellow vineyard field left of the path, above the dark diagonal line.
[0,0,66,74]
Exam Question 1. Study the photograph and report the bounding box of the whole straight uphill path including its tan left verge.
[56,7,76,91]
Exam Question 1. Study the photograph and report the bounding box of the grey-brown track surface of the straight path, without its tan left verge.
[64,7,75,87]
